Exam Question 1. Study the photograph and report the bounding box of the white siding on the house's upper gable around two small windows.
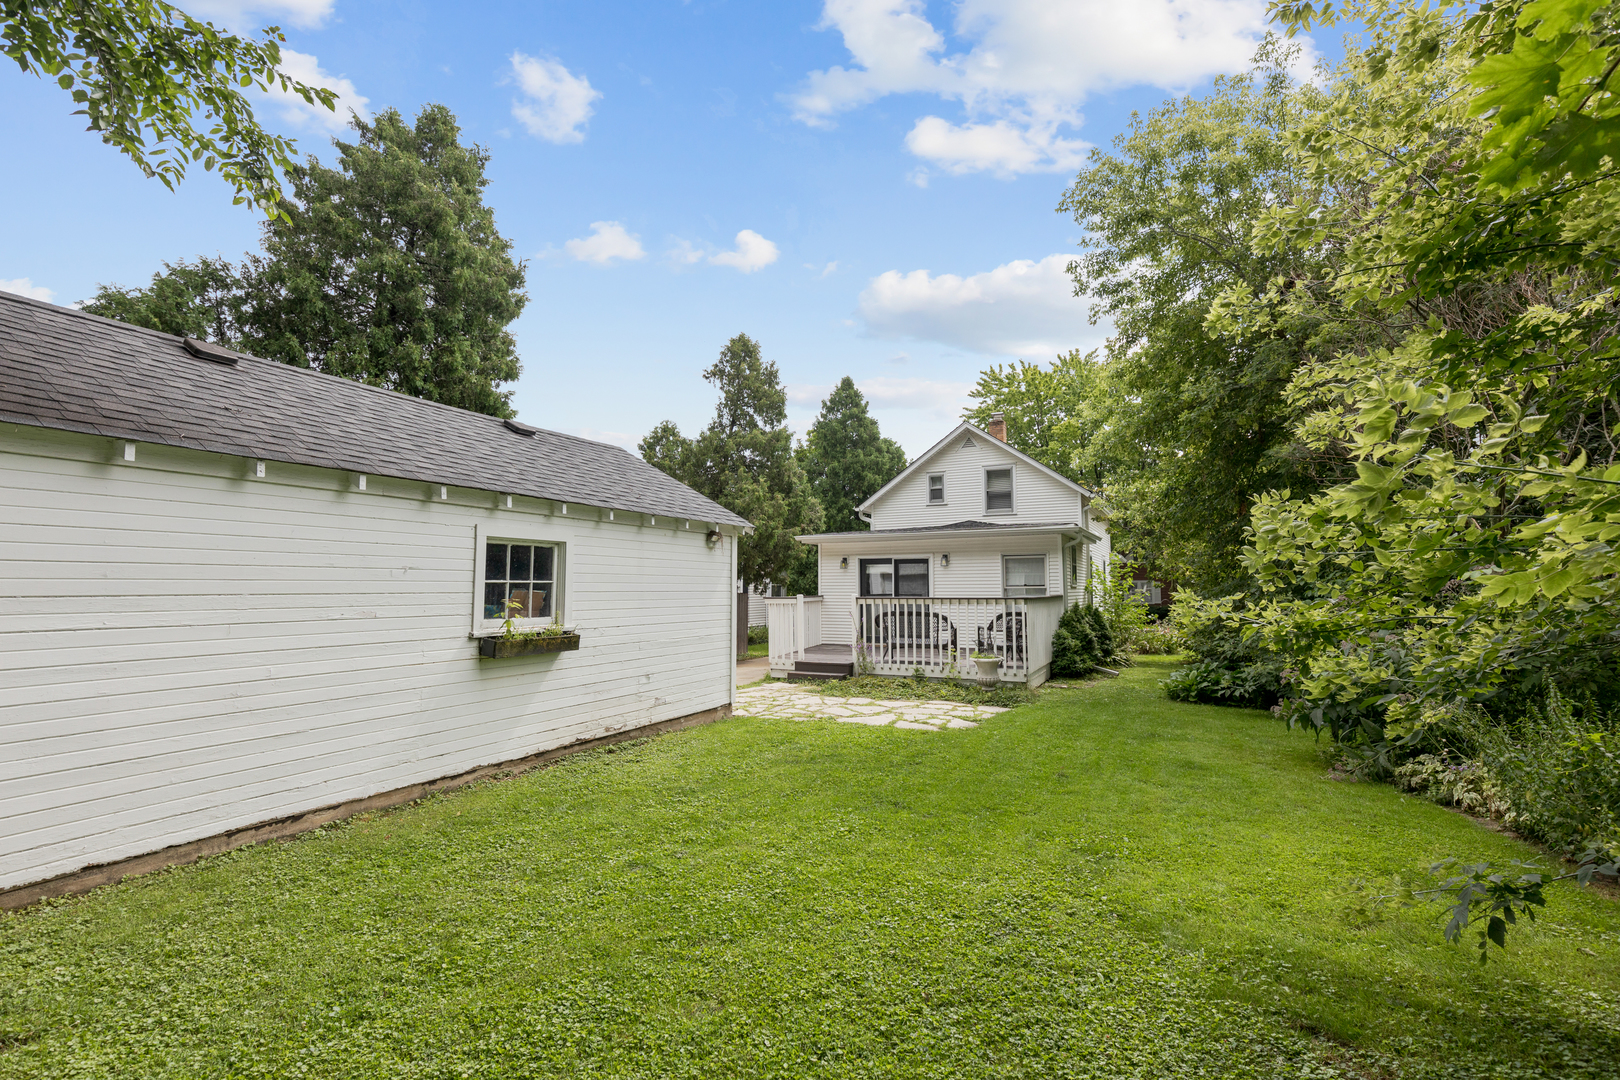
[870,436,1082,529]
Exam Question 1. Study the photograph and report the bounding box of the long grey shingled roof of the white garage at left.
[0,293,752,529]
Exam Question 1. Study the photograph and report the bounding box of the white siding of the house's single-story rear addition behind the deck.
[818,533,1063,644]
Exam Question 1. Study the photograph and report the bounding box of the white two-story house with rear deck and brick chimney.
[766,415,1108,687]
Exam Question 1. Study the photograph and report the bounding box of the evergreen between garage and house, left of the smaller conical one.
[640,334,821,586]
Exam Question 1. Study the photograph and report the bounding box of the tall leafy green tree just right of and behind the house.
[1062,39,1319,588]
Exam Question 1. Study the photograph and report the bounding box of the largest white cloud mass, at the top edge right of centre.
[791,0,1311,176]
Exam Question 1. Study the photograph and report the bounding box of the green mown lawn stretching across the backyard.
[0,659,1620,1080]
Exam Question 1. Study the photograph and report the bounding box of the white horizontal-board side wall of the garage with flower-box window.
[0,424,735,887]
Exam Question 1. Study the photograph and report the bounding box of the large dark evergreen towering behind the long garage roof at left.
[86,105,528,416]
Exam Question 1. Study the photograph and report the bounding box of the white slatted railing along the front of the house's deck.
[851,596,1063,682]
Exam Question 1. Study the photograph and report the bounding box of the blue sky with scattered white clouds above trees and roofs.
[0,0,1315,455]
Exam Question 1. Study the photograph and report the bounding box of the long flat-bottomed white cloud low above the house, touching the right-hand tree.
[859,254,1108,358]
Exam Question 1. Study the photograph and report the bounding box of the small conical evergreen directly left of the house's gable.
[799,376,906,533]
